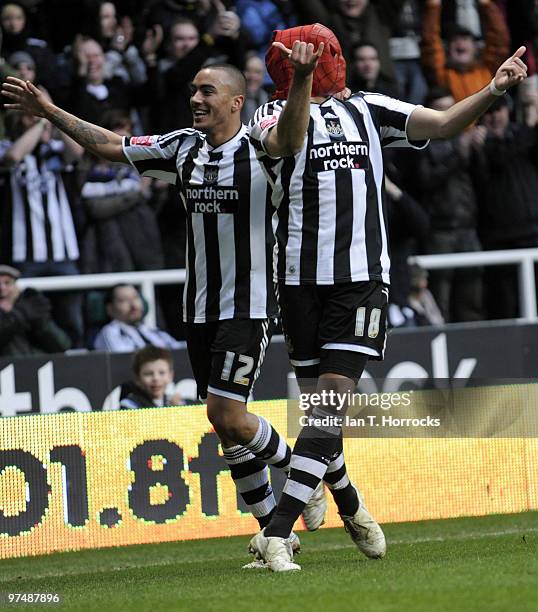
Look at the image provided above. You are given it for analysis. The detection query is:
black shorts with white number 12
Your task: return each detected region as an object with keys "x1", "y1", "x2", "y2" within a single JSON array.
[{"x1": 186, "y1": 319, "x2": 275, "y2": 402}]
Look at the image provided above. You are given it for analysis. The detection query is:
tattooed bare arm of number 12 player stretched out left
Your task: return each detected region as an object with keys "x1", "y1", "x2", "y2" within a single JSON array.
[{"x1": 2, "y1": 77, "x2": 128, "y2": 163}]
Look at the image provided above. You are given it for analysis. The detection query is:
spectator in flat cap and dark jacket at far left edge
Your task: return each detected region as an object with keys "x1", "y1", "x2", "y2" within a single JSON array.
[{"x1": 0, "y1": 265, "x2": 71, "y2": 357}]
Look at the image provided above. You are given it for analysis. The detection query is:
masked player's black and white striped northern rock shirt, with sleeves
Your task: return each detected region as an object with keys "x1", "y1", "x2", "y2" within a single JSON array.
[{"x1": 250, "y1": 92, "x2": 427, "y2": 285}]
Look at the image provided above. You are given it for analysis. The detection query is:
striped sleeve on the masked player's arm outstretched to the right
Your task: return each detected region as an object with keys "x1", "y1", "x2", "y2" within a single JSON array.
[{"x1": 363, "y1": 93, "x2": 429, "y2": 149}]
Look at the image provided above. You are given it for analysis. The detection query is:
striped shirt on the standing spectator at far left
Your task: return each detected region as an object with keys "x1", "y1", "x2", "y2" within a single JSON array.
[{"x1": 0, "y1": 139, "x2": 79, "y2": 264}]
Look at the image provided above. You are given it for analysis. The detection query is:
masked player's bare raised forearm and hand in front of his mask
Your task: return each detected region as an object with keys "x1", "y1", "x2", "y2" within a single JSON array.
[{"x1": 265, "y1": 40, "x2": 324, "y2": 157}]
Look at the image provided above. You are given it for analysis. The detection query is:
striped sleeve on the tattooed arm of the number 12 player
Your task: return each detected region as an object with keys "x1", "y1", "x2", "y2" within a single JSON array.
[{"x1": 123, "y1": 129, "x2": 196, "y2": 184}]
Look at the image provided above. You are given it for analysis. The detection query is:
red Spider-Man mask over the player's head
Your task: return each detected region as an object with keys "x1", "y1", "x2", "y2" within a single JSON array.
[{"x1": 265, "y1": 23, "x2": 346, "y2": 99}]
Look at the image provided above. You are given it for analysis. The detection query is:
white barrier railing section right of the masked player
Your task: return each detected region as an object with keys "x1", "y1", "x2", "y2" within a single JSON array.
[{"x1": 409, "y1": 249, "x2": 538, "y2": 322}]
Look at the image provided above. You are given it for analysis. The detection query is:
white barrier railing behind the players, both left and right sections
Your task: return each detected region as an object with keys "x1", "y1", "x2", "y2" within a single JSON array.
[{"x1": 14, "y1": 249, "x2": 538, "y2": 325}]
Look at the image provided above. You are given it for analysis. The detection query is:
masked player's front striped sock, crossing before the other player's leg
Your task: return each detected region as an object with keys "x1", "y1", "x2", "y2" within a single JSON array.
[{"x1": 264, "y1": 409, "x2": 341, "y2": 538}]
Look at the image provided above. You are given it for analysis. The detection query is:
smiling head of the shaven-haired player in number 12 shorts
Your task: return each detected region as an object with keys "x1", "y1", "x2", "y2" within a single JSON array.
[{"x1": 191, "y1": 67, "x2": 245, "y2": 134}]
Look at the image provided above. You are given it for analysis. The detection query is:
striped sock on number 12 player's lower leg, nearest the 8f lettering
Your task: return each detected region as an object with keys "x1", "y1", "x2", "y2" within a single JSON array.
[{"x1": 223, "y1": 446, "x2": 276, "y2": 529}]
